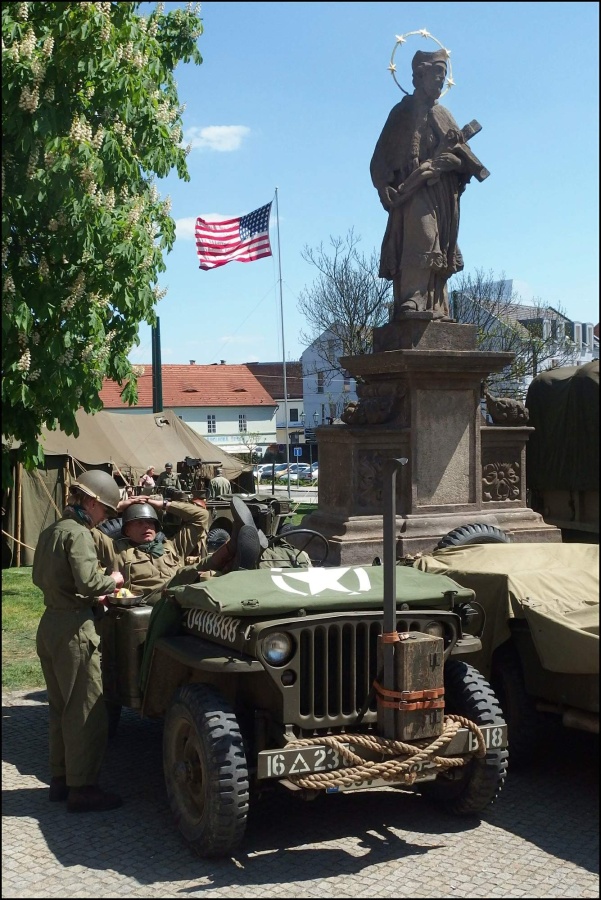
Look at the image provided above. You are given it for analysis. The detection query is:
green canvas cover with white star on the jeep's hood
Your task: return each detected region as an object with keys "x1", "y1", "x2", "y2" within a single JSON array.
[{"x1": 168, "y1": 566, "x2": 473, "y2": 617}]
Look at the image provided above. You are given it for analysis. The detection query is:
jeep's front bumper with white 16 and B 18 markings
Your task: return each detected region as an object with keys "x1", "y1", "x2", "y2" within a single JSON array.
[{"x1": 257, "y1": 725, "x2": 507, "y2": 778}]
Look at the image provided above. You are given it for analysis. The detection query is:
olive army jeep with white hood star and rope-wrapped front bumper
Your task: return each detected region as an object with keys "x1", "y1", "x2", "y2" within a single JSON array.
[{"x1": 100, "y1": 464, "x2": 508, "y2": 856}]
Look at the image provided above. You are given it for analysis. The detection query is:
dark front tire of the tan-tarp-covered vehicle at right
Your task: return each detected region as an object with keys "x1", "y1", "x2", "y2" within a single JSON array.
[{"x1": 490, "y1": 643, "x2": 546, "y2": 766}]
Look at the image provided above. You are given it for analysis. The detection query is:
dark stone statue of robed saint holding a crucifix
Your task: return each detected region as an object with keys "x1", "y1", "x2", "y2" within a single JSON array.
[{"x1": 370, "y1": 50, "x2": 489, "y2": 322}]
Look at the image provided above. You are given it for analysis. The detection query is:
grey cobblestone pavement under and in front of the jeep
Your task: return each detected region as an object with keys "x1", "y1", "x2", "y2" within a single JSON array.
[{"x1": 2, "y1": 691, "x2": 599, "y2": 900}]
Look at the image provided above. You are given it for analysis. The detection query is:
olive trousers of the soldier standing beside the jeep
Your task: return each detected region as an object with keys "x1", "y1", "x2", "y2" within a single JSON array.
[{"x1": 36, "y1": 609, "x2": 108, "y2": 787}]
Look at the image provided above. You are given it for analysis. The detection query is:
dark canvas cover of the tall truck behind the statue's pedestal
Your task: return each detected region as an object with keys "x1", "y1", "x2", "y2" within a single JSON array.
[{"x1": 526, "y1": 359, "x2": 599, "y2": 491}]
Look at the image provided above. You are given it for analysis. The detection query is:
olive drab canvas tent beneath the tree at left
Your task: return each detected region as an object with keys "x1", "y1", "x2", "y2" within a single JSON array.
[{"x1": 2, "y1": 409, "x2": 252, "y2": 568}]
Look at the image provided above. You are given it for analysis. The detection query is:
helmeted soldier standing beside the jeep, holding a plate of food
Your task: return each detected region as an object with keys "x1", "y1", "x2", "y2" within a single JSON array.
[{"x1": 32, "y1": 470, "x2": 123, "y2": 812}]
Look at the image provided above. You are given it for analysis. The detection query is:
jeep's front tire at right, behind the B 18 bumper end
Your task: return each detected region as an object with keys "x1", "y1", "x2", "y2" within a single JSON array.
[{"x1": 421, "y1": 659, "x2": 508, "y2": 816}]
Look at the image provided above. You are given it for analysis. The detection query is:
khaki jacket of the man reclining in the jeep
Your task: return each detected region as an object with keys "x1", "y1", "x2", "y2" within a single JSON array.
[{"x1": 92, "y1": 500, "x2": 209, "y2": 593}]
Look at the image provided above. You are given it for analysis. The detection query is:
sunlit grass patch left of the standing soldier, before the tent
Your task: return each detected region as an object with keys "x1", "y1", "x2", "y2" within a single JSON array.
[{"x1": 2, "y1": 566, "x2": 45, "y2": 691}]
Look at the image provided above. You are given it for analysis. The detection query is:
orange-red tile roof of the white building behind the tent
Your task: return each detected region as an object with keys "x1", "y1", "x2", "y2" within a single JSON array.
[{"x1": 100, "y1": 365, "x2": 275, "y2": 409}]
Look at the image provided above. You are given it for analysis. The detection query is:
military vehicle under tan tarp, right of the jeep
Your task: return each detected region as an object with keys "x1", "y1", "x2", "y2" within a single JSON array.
[{"x1": 411, "y1": 536, "x2": 599, "y2": 764}]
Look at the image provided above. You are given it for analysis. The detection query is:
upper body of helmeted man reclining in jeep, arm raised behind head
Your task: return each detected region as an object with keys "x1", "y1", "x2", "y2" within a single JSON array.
[{"x1": 92, "y1": 496, "x2": 209, "y2": 593}]
